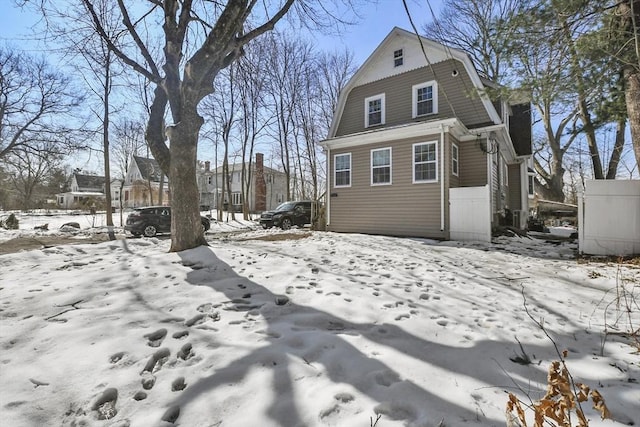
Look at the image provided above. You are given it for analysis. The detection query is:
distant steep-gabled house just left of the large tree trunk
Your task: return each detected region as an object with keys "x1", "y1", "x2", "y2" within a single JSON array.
[{"x1": 122, "y1": 156, "x2": 170, "y2": 208}]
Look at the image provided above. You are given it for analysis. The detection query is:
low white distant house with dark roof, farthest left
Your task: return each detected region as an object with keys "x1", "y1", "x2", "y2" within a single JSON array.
[{"x1": 56, "y1": 173, "x2": 121, "y2": 209}]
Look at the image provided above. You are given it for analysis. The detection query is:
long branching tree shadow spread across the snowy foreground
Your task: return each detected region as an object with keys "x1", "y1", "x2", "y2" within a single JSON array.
[{"x1": 169, "y1": 247, "x2": 620, "y2": 427}]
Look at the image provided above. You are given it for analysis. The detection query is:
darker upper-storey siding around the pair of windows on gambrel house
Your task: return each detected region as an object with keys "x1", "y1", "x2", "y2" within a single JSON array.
[{"x1": 336, "y1": 59, "x2": 491, "y2": 136}]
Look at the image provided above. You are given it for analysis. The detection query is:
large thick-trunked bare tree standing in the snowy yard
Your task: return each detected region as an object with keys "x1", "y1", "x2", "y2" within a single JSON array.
[{"x1": 72, "y1": 0, "x2": 362, "y2": 251}]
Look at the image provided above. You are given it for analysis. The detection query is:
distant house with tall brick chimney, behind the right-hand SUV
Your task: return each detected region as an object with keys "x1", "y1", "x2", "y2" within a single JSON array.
[{"x1": 198, "y1": 153, "x2": 287, "y2": 212}]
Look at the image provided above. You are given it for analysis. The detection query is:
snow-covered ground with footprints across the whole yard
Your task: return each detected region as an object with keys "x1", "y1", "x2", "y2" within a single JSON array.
[{"x1": 0, "y1": 211, "x2": 640, "y2": 427}]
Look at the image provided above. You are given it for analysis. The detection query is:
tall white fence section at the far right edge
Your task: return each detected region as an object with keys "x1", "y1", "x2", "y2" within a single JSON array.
[{"x1": 578, "y1": 180, "x2": 640, "y2": 255}]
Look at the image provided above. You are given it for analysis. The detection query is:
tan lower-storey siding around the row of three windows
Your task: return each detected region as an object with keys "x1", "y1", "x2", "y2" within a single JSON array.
[{"x1": 328, "y1": 134, "x2": 450, "y2": 238}]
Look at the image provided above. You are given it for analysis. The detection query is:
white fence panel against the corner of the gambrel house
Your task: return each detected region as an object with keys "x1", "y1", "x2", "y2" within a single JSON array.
[{"x1": 449, "y1": 185, "x2": 491, "y2": 242}]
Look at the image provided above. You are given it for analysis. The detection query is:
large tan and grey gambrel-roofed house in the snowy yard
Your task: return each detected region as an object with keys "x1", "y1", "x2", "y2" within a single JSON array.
[{"x1": 321, "y1": 28, "x2": 533, "y2": 240}]
